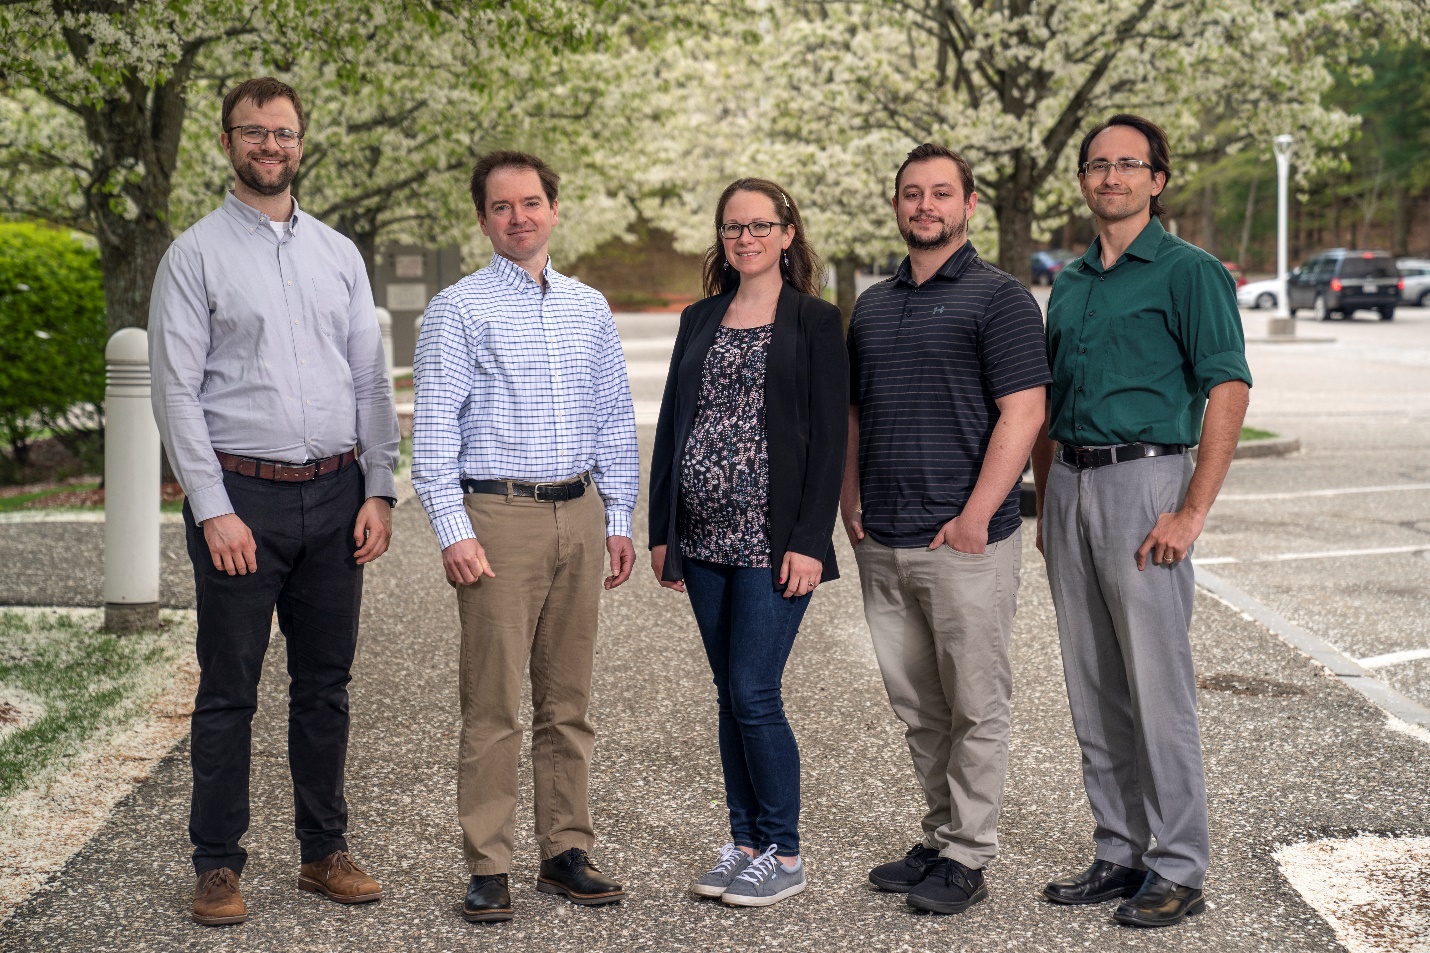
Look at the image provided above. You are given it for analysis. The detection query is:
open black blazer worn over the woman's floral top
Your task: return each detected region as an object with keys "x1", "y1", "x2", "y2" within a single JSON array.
[{"x1": 651, "y1": 283, "x2": 849, "y2": 588}]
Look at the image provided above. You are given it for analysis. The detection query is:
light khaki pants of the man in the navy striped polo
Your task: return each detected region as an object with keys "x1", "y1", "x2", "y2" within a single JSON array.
[{"x1": 854, "y1": 532, "x2": 1022, "y2": 869}]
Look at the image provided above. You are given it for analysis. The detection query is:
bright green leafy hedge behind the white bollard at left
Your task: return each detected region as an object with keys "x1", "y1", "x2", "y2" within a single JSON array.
[{"x1": 0, "y1": 223, "x2": 107, "y2": 465}]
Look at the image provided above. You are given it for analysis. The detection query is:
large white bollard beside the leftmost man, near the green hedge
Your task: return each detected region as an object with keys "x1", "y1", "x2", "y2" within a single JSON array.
[{"x1": 104, "y1": 328, "x2": 159, "y2": 632}]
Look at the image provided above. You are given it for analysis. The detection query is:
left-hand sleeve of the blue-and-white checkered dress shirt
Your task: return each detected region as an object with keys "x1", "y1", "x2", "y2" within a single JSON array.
[{"x1": 412, "y1": 295, "x2": 476, "y2": 549}]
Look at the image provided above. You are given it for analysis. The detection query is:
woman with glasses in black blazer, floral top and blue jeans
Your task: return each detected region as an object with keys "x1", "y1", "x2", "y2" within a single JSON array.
[{"x1": 651, "y1": 179, "x2": 849, "y2": 906}]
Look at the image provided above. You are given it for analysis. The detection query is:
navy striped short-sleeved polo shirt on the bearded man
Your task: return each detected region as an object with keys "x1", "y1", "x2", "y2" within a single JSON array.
[{"x1": 848, "y1": 243, "x2": 1052, "y2": 548}]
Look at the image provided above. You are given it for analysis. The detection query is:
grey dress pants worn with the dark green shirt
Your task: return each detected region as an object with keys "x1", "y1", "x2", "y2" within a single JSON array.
[{"x1": 1042, "y1": 455, "x2": 1211, "y2": 887}]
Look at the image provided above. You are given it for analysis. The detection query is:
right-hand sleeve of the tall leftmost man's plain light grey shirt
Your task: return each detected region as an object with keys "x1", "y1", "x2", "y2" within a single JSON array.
[{"x1": 347, "y1": 256, "x2": 402, "y2": 499}]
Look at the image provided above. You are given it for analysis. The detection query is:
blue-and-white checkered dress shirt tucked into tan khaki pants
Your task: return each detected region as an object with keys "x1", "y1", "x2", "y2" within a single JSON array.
[{"x1": 412, "y1": 255, "x2": 641, "y2": 549}]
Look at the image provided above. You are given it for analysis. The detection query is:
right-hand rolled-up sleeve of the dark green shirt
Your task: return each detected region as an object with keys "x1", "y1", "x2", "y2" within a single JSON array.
[{"x1": 1175, "y1": 260, "x2": 1251, "y2": 396}]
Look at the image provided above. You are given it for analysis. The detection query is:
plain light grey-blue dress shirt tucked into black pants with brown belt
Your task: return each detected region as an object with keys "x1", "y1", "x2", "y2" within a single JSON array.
[{"x1": 149, "y1": 192, "x2": 399, "y2": 522}]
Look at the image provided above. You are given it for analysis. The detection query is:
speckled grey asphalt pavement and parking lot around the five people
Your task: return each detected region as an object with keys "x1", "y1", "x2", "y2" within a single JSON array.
[{"x1": 0, "y1": 311, "x2": 1430, "y2": 952}]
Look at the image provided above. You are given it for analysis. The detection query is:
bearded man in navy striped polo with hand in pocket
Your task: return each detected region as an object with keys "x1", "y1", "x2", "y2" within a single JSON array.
[{"x1": 841, "y1": 143, "x2": 1051, "y2": 913}]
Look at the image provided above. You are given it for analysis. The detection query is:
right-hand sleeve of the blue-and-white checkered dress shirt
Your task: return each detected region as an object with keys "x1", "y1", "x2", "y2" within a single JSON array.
[{"x1": 592, "y1": 302, "x2": 641, "y2": 537}]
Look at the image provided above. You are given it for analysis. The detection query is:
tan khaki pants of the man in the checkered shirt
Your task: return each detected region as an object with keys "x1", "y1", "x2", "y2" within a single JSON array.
[{"x1": 458, "y1": 487, "x2": 606, "y2": 876}]
